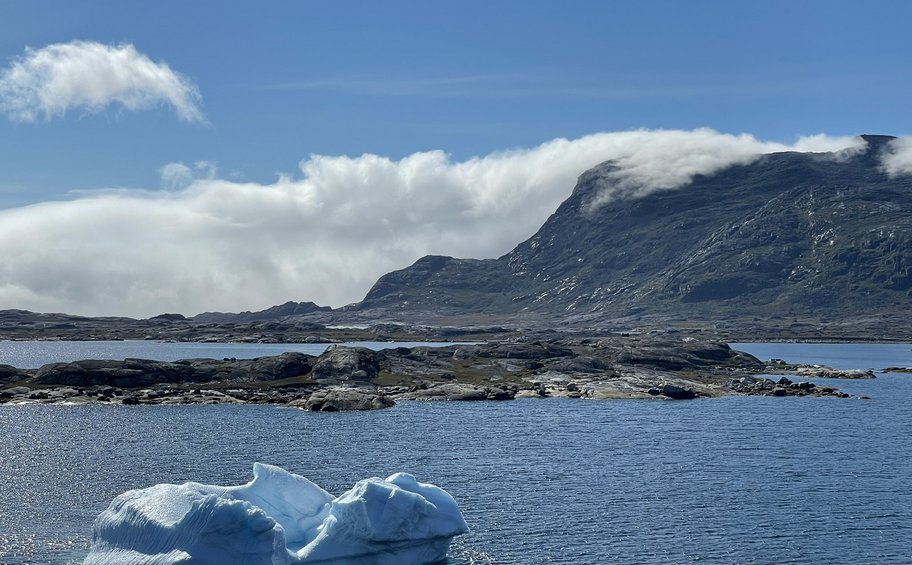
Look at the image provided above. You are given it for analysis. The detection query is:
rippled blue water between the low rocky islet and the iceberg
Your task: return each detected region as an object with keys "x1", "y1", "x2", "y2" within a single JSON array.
[{"x1": 0, "y1": 346, "x2": 912, "y2": 564}]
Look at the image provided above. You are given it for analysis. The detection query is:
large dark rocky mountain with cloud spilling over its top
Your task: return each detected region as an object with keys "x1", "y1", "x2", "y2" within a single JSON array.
[{"x1": 345, "y1": 135, "x2": 912, "y2": 324}]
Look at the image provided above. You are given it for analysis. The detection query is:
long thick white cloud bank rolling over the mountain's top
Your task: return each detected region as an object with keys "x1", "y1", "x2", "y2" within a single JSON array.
[{"x1": 0, "y1": 129, "x2": 856, "y2": 316}]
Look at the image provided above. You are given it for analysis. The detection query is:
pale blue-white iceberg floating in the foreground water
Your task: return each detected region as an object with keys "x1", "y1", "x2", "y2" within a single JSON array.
[{"x1": 84, "y1": 463, "x2": 468, "y2": 565}]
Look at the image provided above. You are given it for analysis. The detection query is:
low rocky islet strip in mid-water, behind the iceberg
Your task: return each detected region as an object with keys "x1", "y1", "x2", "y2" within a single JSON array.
[{"x1": 0, "y1": 335, "x2": 874, "y2": 411}]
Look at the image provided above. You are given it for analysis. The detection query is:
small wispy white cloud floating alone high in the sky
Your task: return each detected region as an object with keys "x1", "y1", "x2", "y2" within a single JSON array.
[{"x1": 0, "y1": 41, "x2": 205, "y2": 122}]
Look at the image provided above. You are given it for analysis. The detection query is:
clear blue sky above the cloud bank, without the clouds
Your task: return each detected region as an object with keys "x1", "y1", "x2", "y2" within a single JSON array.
[{"x1": 0, "y1": 0, "x2": 912, "y2": 207}]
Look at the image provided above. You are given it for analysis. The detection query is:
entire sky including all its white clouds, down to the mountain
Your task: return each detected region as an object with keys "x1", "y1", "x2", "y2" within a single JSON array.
[{"x1": 0, "y1": 0, "x2": 912, "y2": 316}]
